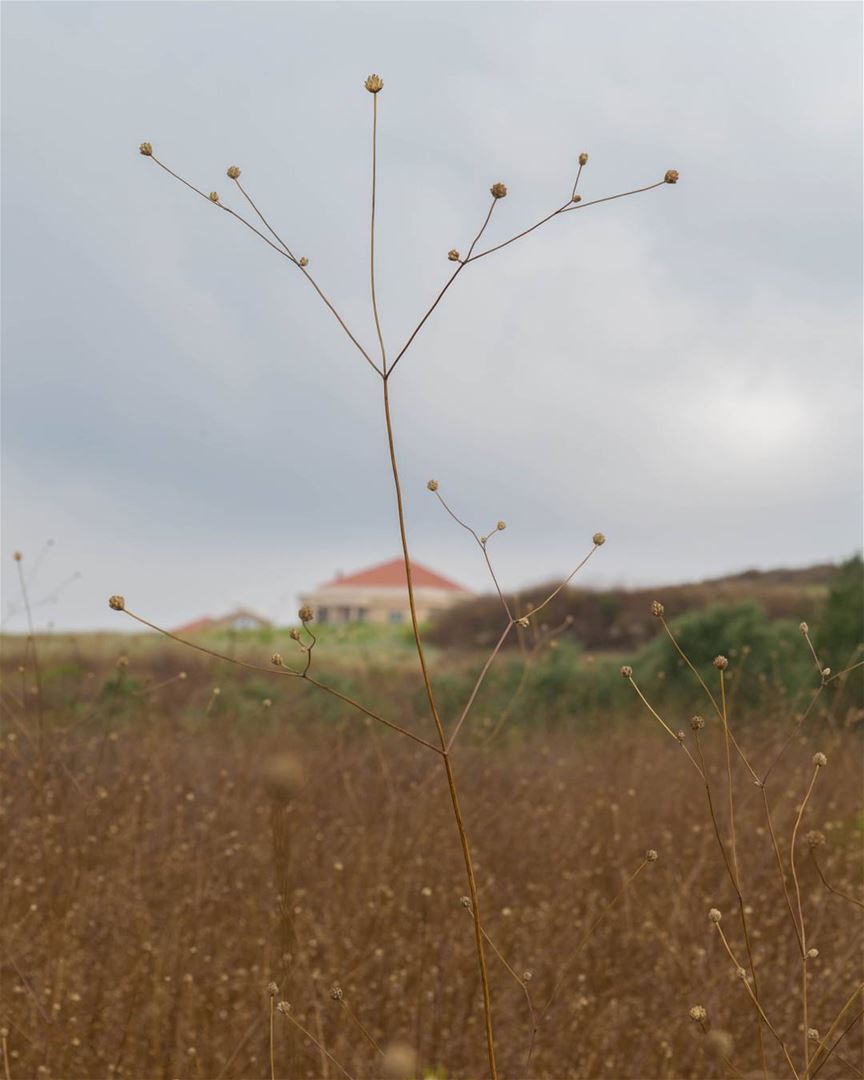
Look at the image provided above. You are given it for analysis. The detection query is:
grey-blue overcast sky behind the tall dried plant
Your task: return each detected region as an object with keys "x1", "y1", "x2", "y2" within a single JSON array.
[{"x1": 2, "y1": 2, "x2": 862, "y2": 629}]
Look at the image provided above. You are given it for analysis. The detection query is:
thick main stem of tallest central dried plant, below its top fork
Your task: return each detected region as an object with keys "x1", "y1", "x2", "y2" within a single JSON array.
[{"x1": 383, "y1": 378, "x2": 498, "y2": 1080}]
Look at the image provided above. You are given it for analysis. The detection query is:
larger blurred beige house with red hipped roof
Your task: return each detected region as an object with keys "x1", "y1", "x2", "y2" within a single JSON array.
[{"x1": 300, "y1": 556, "x2": 472, "y2": 625}]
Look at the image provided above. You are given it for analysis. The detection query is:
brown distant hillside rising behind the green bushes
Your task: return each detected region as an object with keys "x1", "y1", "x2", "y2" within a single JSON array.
[{"x1": 428, "y1": 563, "x2": 837, "y2": 651}]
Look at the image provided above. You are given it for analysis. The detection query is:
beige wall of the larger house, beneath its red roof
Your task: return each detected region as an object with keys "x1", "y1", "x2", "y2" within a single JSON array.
[{"x1": 300, "y1": 585, "x2": 471, "y2": 625}]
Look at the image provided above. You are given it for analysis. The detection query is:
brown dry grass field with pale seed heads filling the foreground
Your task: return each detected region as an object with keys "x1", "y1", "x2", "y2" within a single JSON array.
[{"x1": 0, "y1": 635, "x2": 864, "y2": 1080}]
